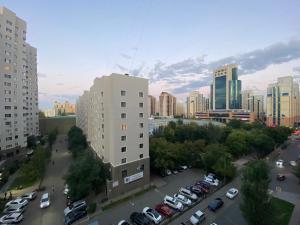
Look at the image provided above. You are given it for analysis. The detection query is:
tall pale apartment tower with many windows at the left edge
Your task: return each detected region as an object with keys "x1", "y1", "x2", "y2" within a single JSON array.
[{"x1": 0, "y1": 7, "x2": 39, "y2": 158}]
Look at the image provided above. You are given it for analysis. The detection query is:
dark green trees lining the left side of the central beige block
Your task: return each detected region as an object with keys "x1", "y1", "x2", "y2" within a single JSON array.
[{"x1": 66, "y1": 126, "x2": 108, "y2": 200}]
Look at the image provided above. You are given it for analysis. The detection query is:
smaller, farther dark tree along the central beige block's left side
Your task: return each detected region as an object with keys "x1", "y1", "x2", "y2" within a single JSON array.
[{"x1": 68, "y1": 126, "x2": 87, "y2": 158}]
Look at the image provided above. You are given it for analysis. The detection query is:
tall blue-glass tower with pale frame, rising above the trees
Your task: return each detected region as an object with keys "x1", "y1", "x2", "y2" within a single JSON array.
[{"x1": 211, "y1": 64, "x2": 242, "y2": 110}]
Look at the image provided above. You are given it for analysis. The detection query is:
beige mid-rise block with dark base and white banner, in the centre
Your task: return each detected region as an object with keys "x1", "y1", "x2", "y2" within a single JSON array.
[{"x1": 76, "y1": 74, "x2": 150, "y2": 198}]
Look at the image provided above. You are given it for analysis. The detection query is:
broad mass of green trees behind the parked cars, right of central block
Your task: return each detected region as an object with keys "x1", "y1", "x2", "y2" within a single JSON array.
[{"x1": 150, "y1": 120, "x2": 291, "y2": 178}]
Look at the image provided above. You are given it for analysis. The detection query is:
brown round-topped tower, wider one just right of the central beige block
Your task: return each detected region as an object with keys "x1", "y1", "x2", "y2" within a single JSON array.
[{"x1": 159, "y1": 92, "x2": 176, "y2": 117}]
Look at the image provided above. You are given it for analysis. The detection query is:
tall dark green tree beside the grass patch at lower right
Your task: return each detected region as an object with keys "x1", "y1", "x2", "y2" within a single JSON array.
[{"x1": 240, "y1": 160, "x2": 274, "y2": 225}]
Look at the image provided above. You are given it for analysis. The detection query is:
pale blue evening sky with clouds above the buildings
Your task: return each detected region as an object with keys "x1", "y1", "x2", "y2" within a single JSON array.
[{"x1": 0, "y1": 0, "x2": 300, "y2": 109}]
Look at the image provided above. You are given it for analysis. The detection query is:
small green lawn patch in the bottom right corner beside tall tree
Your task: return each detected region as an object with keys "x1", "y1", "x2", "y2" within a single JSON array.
[{"x1": 271, "y1": 197, "x2": 295, "y2": 225}]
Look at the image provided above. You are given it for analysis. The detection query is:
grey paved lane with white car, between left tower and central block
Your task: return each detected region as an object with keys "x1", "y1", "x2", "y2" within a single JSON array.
[{"x1": 21, "y1": 135, "x2": 72, "y2": 225}]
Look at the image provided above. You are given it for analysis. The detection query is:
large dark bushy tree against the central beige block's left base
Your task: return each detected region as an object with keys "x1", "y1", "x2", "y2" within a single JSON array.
[{"x1": 66, "y1": 152, "x2": 108, "y2": 200}]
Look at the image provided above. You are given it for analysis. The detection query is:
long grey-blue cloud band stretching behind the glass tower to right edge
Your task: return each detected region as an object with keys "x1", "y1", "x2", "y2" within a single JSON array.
[{"x1": 126, "y1": 40, "x2": 300, "y2": 94}]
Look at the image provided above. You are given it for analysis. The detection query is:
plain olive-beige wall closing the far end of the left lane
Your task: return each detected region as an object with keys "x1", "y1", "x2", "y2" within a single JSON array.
[{"x1": 40, "y1": 116, "x2": 76, "y2": 135}]
